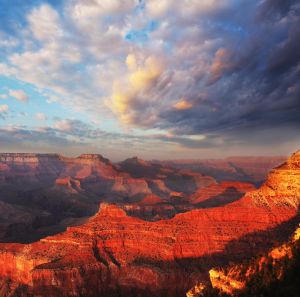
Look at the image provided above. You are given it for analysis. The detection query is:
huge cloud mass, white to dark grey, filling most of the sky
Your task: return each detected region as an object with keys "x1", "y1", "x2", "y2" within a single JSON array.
[{"x1": 0, "y1": 0, "x2": 300, "y2": 157}]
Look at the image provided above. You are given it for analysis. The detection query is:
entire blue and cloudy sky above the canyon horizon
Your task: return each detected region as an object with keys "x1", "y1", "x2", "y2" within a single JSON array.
[{"x1": 0, "y1": 0, "x2": 300, "y2": 160}]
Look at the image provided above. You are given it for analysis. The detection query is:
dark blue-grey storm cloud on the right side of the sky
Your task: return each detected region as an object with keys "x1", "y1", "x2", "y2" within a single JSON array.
[{"x1": 144, "y1": 1, "x2": 300, "y2": 146}]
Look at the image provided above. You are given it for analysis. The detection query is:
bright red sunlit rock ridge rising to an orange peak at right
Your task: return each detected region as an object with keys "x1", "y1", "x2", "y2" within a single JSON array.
[{"x1": 0, "y1": 152, "x2": 300, "y2": 297}]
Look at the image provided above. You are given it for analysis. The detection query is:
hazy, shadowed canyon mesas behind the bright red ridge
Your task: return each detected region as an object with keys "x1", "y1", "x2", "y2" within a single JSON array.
[{"x1": 0, "y1": 153, "x2": 268, "y2": 243}]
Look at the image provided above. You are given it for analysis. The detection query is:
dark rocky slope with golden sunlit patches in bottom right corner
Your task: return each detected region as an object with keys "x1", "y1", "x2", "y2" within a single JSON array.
[{"x1": 186, "y1": 227, "x2": 300, "y2": 297}]
